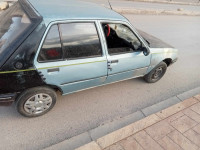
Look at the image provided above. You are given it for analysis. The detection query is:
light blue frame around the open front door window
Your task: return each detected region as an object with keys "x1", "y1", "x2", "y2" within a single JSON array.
[{"x1": 99, "y1": 20, "x2": 149, "y2": 56}]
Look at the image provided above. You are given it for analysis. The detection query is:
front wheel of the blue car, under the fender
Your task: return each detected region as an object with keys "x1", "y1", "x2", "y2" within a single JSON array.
[{"x1": 144, "y1": 62, "x2": 167, "y2": 83}]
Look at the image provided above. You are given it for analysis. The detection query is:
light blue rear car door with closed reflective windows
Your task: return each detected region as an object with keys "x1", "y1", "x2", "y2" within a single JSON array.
[{"x1": 35, "y1": 22, "x2": 107, "y2": 94}]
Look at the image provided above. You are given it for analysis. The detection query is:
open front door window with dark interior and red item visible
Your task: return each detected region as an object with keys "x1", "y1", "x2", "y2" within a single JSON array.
[{"x1": 102, "y1": 23, "x2": 142, "y2": 55}]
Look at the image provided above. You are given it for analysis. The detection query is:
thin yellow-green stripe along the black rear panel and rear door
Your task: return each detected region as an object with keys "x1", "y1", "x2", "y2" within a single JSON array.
[{"x1": 0, "y1": 60, "x2": 107, "y2": 74}]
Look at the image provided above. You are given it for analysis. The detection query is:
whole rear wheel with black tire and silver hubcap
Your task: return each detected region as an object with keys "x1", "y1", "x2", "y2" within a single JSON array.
[{"x1": 16, "y1": 87, "x2": 57, "y2": 117}]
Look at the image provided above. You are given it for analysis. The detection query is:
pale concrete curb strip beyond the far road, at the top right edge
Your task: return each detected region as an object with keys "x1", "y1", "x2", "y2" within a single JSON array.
[{"x1": 127, "y1": 0, "x2": 200, "y2": 6}]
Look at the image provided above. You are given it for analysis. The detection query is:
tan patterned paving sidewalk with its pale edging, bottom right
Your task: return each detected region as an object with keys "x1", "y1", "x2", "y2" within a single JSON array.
[{"x1": 76, "y1": 95, "x2": 200, "y2": 150}]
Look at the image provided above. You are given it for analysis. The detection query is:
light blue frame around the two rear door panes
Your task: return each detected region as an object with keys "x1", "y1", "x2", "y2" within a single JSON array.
[{"x1": 35, "y1": 20, "x2": 106, "y2": 63}]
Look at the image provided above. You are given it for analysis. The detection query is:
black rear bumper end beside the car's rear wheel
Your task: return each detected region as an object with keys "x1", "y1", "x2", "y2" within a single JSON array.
[{"x1": 0, "y1": 93, "x2": 17, "y2": 106}]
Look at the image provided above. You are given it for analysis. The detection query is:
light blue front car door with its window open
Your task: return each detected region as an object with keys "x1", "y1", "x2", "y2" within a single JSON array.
[{"x1": 101, "y1": 21, "x2": 151, "y2": 83}]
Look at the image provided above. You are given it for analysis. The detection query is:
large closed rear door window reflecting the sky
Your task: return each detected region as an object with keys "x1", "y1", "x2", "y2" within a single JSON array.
[{"x1": 59, "y1": 23, "x2": 102, "y2": 59}]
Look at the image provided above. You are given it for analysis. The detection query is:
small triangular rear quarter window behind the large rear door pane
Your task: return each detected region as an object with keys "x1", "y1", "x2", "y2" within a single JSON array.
[{"x1": 38, "y1": 25, "x2": 63, "y2": 62}]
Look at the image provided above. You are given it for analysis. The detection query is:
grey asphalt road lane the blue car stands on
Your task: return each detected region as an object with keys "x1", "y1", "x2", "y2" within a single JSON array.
[{"x1": 0, "y1": 15, "x2": 200, "y2": 150}]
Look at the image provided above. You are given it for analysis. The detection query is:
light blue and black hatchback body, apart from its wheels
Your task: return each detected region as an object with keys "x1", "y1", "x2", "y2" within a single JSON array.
[{"x1": 0, "y1": 0, "x2": 178, "y2": 117}]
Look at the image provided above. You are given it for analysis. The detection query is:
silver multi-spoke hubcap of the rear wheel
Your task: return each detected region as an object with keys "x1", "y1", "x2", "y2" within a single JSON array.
[{"x1": 24, "y1": 93, "x2": 52, "y2": 114}]
